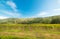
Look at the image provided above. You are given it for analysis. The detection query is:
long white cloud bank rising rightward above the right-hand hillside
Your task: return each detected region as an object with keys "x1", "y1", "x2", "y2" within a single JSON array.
[{"x1": 32, "y1": 8, "x2": 60, "y2": 17}]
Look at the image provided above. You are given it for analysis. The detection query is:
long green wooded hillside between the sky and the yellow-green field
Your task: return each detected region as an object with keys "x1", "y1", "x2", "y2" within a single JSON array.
[{"x1": 0, "y1": 15, "x2": 60, "y2": 24}]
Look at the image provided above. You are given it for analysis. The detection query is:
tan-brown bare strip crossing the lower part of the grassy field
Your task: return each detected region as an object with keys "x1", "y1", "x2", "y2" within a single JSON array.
[{"x1": 0, "y1": 32, "x2": 60, "y2": 39}]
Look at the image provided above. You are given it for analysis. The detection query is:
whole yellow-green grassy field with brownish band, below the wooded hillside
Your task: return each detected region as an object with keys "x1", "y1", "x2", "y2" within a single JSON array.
[{"x1": 0, "y1": 24, "x2": 60, "y2": 39}]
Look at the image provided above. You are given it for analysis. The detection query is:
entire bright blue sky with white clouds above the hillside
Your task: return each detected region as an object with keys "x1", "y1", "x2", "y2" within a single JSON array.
[{"x1": 0, "y1": 0, "x2": 60, "y2": 19}]
